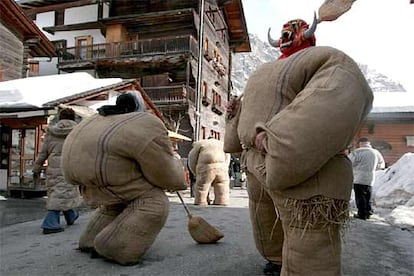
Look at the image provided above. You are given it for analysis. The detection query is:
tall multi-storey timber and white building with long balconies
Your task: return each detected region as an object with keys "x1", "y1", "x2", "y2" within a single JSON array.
[{"x1": 18, "y1": 0, "x2": 250, "y2": 157}]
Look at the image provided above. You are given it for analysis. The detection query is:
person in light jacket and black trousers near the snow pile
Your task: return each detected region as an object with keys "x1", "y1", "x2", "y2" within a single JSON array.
[{"x1": 348, "y1": 137, "x2": 385, "y2": 220}]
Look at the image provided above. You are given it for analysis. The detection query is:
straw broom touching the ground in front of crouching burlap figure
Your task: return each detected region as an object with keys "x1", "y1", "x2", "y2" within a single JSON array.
[{"x1": 176, "y1": 192, "x2": 224, "y2": 244}]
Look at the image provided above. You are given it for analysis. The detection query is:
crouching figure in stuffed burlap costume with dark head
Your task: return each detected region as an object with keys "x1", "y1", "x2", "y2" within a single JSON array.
[{"x1": 62, "y1": 93, "x2": 187, "y2": 265}]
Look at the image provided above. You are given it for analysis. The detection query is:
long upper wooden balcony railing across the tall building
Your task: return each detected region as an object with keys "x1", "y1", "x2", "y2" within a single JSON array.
[{"x1": 59, "y1": 36, "x2": 198, "y2": 65}]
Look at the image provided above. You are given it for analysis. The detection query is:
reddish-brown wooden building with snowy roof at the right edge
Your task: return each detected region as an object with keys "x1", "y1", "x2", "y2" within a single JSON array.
[{"x1": 353, "y1": 92, "x2": 414, "y2": 167}]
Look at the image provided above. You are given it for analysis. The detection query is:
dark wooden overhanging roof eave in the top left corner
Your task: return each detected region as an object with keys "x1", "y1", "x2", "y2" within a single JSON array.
[{"x1": 0, "y1": 0, "x2": 55, "y2": 57}]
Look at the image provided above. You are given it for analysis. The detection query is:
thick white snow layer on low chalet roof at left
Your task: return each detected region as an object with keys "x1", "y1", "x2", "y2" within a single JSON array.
[{"x1": 0, "y1": 72, "x2": 122, "y2": 108}]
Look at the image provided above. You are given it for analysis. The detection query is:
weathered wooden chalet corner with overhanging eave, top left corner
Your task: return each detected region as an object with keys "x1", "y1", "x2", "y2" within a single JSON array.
[{"x1": 0, "y1": 0, "x2": 55, "y2": 81}]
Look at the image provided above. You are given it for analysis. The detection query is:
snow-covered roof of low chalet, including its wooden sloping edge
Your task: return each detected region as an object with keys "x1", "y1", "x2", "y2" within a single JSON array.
[{"x1": 0, "y1": 72, "x2": 164, "y2": 121}]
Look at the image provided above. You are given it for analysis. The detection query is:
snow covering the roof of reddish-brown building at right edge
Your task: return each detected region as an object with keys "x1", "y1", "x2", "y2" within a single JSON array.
[{"x1": 371, "y1": 92, "x2": 414, "y2": 113}]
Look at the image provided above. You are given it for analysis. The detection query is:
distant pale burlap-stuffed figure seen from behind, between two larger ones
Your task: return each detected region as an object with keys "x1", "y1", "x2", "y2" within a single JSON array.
[{"x1": 188, "y1": 139, "x2": 230, "y2": 206}]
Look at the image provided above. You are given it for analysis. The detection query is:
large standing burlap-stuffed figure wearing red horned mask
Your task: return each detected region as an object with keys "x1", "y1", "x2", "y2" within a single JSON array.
[{"x1": 224, "y1": 19, "x2": 373, "y2": 276}]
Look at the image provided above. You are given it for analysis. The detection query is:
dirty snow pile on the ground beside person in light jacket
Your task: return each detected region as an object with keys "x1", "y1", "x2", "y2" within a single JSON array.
[{"x1": 373, "y1": 153, "x2": 414, "y2": 226}]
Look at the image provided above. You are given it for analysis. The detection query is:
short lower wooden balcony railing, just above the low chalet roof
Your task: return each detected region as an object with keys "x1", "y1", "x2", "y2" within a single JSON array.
[{"x1": 144, "y1": 85, "x2": 195, "y2": 104}]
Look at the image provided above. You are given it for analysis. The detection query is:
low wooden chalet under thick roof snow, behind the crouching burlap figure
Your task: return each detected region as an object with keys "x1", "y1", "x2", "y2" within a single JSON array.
[{"x1": 0, "y1": 73, "x2": 164, "y2": 197}]
